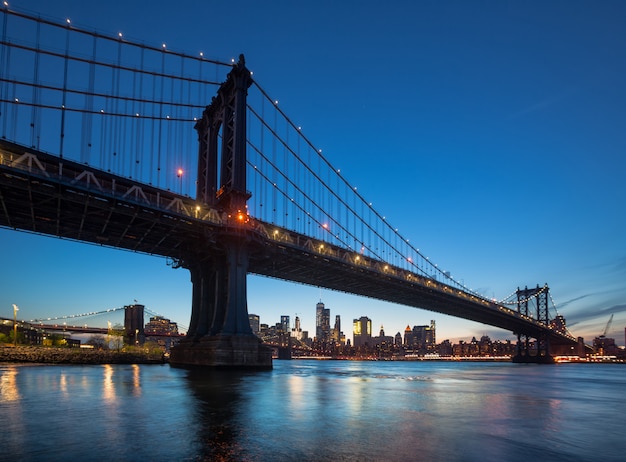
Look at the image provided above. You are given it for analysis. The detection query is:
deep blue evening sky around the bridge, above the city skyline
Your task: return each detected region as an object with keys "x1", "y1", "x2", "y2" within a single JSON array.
[{"x1": 0, "y1": 0, "x2": 626, "y2": 345}]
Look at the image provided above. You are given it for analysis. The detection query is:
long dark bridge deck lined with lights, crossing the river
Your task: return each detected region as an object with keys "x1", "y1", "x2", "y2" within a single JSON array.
[{"x1": 0, "y1": 140, "x2": 576, "y2": 344}]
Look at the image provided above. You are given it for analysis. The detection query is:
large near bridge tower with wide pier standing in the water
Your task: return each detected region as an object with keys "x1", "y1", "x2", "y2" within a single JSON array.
[{"x1": 170, "y1": 55, "x2": 272, "y2": 368}]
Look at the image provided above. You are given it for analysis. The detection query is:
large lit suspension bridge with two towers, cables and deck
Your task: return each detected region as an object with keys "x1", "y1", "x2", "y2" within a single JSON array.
[{"x1": 0, "y1": 5, "x2": 581, "y2": 367}]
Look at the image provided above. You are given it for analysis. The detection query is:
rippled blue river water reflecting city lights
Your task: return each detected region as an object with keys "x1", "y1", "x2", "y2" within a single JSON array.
[{"x1": 0, "y1": 360, "x2": 626, "y2": 462}]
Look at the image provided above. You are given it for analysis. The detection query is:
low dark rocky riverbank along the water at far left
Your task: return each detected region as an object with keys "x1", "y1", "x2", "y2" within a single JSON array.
[{"x1": 0, "y1": 345, "x2": 167, "y2": 364}]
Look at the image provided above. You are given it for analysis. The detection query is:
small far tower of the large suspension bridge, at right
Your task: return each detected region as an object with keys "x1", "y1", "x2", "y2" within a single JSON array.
[{"x1": 513, "y1": 284, "x2": 553, "y2": 363}]
